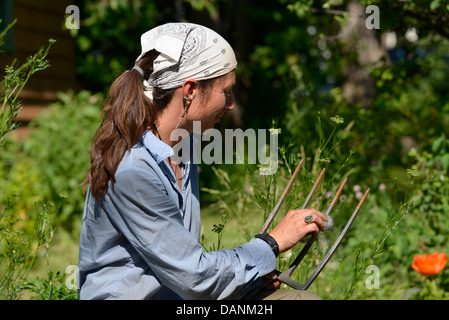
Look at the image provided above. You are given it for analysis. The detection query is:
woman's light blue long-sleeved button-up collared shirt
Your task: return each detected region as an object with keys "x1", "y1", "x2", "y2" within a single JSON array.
[{"x1": 78, "y1": 131, "x2": 276, "y2": 299}]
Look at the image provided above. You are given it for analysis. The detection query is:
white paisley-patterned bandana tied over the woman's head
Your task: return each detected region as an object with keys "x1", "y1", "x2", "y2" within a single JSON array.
[{"x1": 136, "y1": 23, "x2": 237, "y2": 98}]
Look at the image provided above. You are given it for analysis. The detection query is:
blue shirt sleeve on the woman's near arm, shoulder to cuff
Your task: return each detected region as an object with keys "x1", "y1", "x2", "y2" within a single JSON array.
[{"x1": 105, "y1": 168, "x2": 276, "y2": 299}]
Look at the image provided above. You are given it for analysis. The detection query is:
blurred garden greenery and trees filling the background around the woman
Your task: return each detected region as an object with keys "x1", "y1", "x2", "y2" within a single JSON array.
[{"x1": 0, "y1": 0, "x2": 449, "y2": 299}]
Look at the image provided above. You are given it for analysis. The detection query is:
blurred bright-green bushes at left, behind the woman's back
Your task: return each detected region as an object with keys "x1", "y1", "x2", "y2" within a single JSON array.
[{"x1": 0, "y1": 88, "x2": 101, "y2": 299}]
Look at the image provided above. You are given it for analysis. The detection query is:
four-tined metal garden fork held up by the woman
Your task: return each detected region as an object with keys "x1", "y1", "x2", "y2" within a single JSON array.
[{"x1": 259, "y1": 160, "x2": 370, "y2": 290}]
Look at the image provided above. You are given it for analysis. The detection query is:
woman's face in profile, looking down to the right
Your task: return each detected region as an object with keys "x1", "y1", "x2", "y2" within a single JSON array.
[{"x1": 186, "y1": 71, "x2": 235, "y2": 132}]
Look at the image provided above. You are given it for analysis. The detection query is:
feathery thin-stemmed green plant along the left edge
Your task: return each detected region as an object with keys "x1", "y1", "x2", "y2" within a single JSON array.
[{"x1": 0, "y1": 22, "x2": 65, "y2": 299}]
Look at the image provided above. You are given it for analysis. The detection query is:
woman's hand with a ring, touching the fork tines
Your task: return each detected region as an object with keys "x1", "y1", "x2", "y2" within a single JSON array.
[{"x1": 270, "y1": 209, "x2": 327, "y2": 252}]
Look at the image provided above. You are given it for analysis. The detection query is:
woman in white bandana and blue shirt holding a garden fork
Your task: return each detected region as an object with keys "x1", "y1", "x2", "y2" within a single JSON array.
[{"x1": 78, "y1": 23, "x2": 326, "y2": 299}]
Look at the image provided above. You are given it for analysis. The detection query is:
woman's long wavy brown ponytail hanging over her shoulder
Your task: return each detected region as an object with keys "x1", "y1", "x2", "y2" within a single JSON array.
[{"x1": 82, "y1": 50, "x2": 162, "y2": 200}]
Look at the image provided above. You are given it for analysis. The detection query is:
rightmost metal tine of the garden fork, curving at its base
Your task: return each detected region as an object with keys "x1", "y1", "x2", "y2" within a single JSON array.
[{"x1": 279, "y1": 189, "x2": 370, "y2": 290}]
